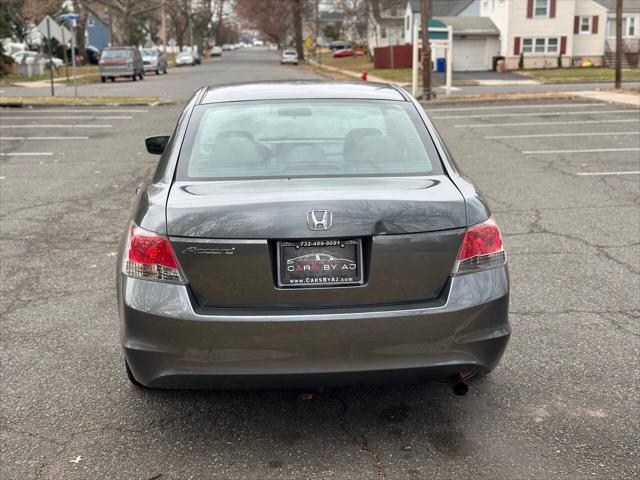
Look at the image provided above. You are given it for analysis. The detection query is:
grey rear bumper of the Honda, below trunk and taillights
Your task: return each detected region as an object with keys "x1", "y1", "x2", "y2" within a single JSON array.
[{"x1": 119, "y1": 267, "x2": 511, "y2": 388}]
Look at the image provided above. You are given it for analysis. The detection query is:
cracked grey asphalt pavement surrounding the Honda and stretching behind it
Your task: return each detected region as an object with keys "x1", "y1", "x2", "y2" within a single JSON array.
[{"x1": 0, "y1": 47, "x2": 640, "y2": 480}]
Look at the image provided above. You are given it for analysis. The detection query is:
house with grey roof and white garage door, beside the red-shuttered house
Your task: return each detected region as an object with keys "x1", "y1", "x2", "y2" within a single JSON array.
[{"x1": 404, "y1": 0, "x2": 500, "y2": 71}]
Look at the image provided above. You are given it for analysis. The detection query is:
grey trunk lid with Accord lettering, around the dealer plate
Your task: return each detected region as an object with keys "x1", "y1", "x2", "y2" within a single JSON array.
[{"x1": 167, "y1": 176, "x2": 466, "y2": 308}]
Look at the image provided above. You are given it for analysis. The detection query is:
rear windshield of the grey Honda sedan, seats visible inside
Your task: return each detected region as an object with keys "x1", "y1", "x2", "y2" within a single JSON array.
[{"x1": 178, "y1": 100, "x2": 442, "y2": 180}]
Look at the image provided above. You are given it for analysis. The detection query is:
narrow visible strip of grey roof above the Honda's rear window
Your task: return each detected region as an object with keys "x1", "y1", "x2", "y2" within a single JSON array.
[{"x1": 200, "y1": 80, "x2": 407, "y2": 104}]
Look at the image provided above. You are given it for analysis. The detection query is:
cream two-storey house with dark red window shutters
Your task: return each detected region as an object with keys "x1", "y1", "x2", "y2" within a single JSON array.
[{"x1": 482, "y1": 0, "x2": 640, "y2": 69}]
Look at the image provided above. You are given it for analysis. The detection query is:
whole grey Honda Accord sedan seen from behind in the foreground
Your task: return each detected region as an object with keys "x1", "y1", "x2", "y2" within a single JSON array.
[{"x1": 117, "y1": 82, "x2": 511, "y2": 393}]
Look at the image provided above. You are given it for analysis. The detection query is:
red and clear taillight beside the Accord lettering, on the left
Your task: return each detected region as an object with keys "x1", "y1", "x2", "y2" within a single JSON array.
[{"x1": 122, "y1": 224, "x2": 184, "y2": 283}]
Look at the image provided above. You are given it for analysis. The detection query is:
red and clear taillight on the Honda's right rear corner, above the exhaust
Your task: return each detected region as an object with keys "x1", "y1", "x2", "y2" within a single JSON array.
[{"x1": 453, "y1": 219, "x2": 507, "y2": 275}]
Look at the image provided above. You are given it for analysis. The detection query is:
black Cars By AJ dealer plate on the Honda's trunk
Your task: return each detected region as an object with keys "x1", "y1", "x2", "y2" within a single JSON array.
[{"x1": 278, "y1": 239, "x2": 363, "y2": 287}]
